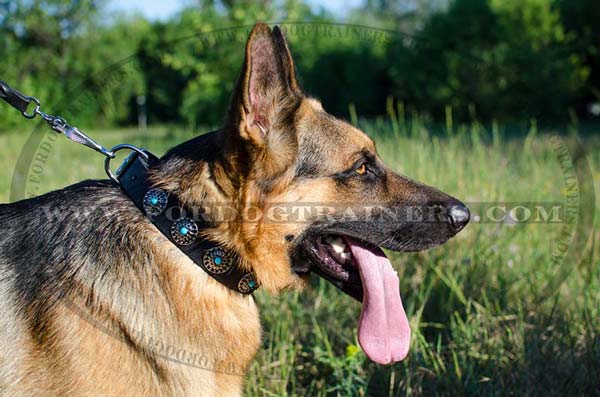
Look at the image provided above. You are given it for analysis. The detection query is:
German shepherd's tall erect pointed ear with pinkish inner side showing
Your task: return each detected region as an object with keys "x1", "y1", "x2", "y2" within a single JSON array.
[{"x1": 230, "y1": 23, "x2": 301, "y2": 146}]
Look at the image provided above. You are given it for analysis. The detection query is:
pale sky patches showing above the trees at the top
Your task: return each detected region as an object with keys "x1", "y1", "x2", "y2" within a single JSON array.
[{"x1": 109, "y1": 0, "x2": 362, "y2": 20}]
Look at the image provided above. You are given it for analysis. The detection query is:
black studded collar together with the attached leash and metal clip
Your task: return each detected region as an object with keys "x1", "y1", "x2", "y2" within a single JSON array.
[{"x1": 0, "y1": 81, "x2": 259, "y2": 294}]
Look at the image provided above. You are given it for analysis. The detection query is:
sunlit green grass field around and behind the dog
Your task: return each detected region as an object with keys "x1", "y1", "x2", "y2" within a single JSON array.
[{"x1": 0, "y1": 118, "x2": 600, "y2": 396}]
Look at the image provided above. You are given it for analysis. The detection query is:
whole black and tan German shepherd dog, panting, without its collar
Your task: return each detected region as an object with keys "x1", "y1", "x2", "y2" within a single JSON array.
[{"x1": 0, "y1": 24, "x2": 469, "y2": 397}]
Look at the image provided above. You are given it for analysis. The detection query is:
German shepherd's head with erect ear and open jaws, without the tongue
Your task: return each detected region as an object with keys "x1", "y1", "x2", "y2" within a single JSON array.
[{"x1": 220, "y1": 24, "x2": 469, "y2": 290}]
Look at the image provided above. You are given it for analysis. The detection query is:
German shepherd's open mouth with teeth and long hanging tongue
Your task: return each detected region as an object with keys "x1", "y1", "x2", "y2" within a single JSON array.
[{"x1": 294, "y1": 234, "x2": 410, "y2": 364}]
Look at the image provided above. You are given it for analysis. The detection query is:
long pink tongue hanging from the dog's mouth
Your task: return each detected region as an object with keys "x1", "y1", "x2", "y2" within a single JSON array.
[{"x1": 347, "y1": 239, "x2": 410, "y2": 364}]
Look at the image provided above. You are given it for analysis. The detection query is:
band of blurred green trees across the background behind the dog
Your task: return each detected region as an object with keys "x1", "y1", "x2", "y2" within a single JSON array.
[{"x1": 0, "y1": 0, "x2": 600, "y2": 129}]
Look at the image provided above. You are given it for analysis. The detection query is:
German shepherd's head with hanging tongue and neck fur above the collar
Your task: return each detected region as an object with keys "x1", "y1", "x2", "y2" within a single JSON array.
[{"x1": 158, "y1": 24, "x2": 469, "y2": 363}]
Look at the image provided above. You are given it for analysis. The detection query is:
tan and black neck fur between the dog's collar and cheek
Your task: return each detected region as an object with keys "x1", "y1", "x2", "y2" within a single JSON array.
[{"x1": 151, "y1": 129, "x2": 303, "y2": 293}]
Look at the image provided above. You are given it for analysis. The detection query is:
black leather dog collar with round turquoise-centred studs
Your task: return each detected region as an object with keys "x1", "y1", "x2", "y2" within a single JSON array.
[{"x1": 117, "y1": 151, "x2": 259, "y2": 294}]
